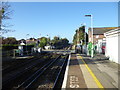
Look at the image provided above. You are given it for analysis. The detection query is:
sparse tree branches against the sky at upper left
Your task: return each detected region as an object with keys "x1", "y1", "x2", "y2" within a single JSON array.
[{"x1": 0, "y1": 2, "x2": 14, "y2": 35}]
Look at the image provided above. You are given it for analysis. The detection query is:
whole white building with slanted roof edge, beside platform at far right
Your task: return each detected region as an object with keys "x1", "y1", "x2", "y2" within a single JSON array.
[{"x1": 104, "y1": 28, "x2": 120, "y2": 64}]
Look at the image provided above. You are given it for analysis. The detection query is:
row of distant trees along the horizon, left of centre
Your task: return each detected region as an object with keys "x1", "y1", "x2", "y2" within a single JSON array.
[{"x1": 0, "y1": 36, "x2": 70, "y2": 49}]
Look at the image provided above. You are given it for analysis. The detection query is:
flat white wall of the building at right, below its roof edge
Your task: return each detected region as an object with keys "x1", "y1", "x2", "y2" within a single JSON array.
[{"x1": 105, "y1": 31, "x2": 120, "y2": 63}]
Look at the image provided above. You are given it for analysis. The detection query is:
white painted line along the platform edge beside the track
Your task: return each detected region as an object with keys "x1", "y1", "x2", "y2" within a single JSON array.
[{"x1": 61, "y1": 54, "x2": 71, "y2": 90}]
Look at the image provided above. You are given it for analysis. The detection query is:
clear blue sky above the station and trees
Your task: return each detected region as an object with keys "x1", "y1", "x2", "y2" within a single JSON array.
[{"x1": 3, "y1": 2, "x2": 118, "y2": 42}]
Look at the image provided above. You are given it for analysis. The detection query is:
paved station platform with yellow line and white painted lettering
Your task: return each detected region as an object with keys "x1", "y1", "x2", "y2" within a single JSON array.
[{"x1": 62, "y1": 53, "x2": 118, "y2": 90}]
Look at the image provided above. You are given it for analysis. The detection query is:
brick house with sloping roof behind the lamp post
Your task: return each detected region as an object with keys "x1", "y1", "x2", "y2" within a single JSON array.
[{"x1": 88, "y1": 27, "x2": 118, "y2": 53}]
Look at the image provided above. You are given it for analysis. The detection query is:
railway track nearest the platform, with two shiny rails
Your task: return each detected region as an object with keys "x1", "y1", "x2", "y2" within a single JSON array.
[{"x1": 17, "y1": 56, "x2": 68, "y2": 90}]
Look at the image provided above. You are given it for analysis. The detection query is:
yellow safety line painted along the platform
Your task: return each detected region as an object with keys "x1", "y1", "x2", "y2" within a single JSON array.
[{"x1": 80, "y1": 53, "x2": 104, "y2": 90}]
